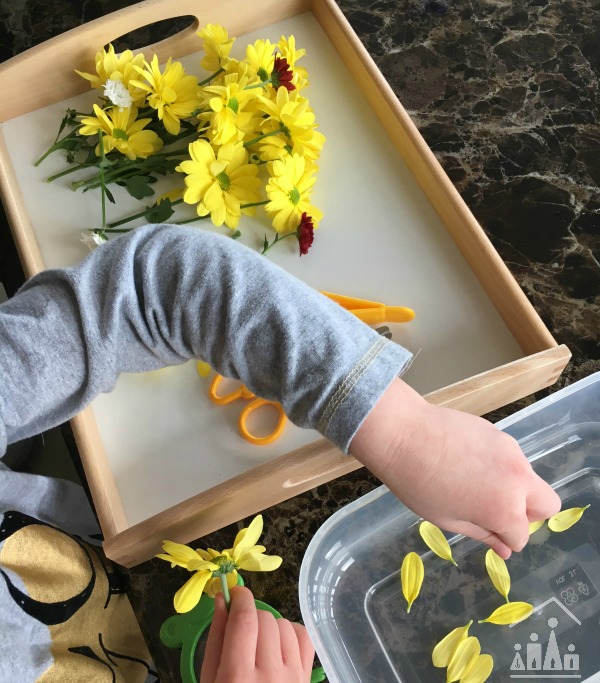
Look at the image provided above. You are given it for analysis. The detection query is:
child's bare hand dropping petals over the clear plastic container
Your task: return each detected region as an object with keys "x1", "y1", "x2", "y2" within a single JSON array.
[{"x1": 350, "y1": 379, "x2": 561, "y2": 559}]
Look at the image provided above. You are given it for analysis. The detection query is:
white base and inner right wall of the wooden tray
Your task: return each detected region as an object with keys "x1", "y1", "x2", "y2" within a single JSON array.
[{"x1": 1, "y1": 13, "x2": 523, "y2": 524}]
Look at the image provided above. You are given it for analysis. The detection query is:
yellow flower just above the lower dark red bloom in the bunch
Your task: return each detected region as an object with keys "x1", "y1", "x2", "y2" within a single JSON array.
[{"x1": 265, "y1": 154, "x2": 323, "y2": 233}]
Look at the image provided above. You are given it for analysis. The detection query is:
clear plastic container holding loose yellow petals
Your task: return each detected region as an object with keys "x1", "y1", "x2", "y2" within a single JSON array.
[{"x1": 299, "y1": 373, "x2": 600, "y2": 683}]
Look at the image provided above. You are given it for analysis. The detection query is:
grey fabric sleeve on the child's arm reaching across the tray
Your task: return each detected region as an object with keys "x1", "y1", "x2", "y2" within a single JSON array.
[{"x1": 0, "y1": 225, "x2": 410, "y2": 455}]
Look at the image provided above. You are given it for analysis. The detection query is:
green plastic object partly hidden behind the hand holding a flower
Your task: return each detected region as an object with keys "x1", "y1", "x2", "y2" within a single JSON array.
[{"x1": 160, "y1": 574, "x2": 325, "y2": 683}]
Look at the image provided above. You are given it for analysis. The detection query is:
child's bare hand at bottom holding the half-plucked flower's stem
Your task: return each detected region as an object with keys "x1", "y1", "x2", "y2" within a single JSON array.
[{"x1": 200, "y1": 586, "x2": 315, "y2": 683}]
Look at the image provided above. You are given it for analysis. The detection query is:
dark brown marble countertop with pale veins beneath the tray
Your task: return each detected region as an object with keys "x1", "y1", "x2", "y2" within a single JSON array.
[{"x1": 0, "y1": 0, "x2": 600, "y2": 681}]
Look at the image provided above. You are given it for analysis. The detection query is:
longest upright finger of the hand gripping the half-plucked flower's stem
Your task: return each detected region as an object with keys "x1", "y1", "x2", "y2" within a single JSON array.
[{"x1": 223, "y1": 586, "x2": 258, "y2": 671}]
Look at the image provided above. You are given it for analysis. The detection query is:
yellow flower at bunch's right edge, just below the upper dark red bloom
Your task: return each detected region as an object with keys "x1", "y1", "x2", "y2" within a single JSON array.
[{"x1": 259, "y1": 88, "x2": 325, "y2": 161}]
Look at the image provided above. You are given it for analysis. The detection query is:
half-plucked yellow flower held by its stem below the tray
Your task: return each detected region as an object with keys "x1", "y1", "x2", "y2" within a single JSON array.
[{"x1": 156, "y1": 515, "x2": 283, "y2": 612}]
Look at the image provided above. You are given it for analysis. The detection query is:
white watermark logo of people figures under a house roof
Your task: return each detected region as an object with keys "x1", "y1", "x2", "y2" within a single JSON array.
[{"x1": 510, "y1": 597, "x2": 581, "y2": 681}]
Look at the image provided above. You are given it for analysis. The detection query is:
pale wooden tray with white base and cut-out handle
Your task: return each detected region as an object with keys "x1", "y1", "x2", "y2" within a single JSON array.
[{"x1": 0, "y1": 0, "x2": 570, "y2": 566}]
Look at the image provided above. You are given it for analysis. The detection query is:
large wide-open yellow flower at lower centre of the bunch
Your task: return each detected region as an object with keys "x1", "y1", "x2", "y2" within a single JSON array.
[{"x1": 176, "y1": 140, "x2": 260, "y2": 229}]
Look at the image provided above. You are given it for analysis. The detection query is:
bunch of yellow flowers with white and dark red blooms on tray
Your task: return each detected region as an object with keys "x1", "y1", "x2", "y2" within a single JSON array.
[{"x1": 37, "y1": 24, "x2": 325, "y2": 255}]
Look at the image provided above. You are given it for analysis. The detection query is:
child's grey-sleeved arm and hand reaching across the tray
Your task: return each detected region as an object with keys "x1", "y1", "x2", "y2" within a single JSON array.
[{"x1": 0, "y1": 226, "x2": 559, "y2": 556}]
